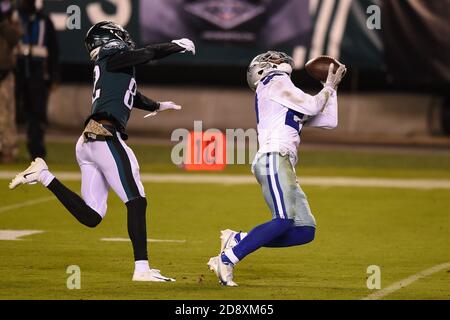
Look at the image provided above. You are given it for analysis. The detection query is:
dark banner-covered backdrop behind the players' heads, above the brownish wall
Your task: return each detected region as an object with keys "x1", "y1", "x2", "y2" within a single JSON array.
[{"x1": 39, "y1": 0, "x2": 450, "y2": 139}]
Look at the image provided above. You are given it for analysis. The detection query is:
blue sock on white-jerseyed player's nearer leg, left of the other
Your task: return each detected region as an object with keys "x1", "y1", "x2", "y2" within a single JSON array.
[{"x1": 227, "y1": 219, "x2": 294, "y2": 261}]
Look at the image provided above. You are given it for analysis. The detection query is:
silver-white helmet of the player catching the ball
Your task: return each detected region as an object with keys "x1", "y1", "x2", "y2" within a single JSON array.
[{"x1": 247, "y1": 51, "x2": 294, "y2": 91}]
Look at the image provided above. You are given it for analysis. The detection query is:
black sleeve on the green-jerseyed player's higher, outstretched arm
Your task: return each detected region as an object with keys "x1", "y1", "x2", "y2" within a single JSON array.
[{"x1": 106, "y1": 42, "x2": 184, "y2": 71}]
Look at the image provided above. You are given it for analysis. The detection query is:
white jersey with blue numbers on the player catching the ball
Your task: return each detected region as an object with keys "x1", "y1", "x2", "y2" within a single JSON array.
[{"x1": 255, "y1": 71, "x2": 337, "y2": 165}]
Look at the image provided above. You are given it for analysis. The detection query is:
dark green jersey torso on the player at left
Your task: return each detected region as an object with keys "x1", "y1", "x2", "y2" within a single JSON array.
[{"x1": 91, "y1": 40, "x2": 137, "y2": 131}]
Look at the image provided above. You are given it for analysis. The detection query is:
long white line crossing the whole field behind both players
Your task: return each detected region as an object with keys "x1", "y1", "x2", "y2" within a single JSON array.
[{"x1": 0, "y1": 171, "x2": 450, "y2": 189}]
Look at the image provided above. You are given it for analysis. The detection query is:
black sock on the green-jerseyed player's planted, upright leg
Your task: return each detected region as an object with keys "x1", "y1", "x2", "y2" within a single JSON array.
[{"x1": 126, "y1": 197, "x2": 148, "y2": 261}]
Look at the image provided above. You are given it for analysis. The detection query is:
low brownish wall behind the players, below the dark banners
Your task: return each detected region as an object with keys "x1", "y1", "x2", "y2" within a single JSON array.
[{"x1": 49, "y1": 84, "x2": 440, "y2": 137}]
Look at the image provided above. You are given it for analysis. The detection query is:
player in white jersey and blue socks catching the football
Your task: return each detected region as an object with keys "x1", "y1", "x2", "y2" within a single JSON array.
[{"x1": 208, "y1": 51, "x2": 346, "y2": 286}]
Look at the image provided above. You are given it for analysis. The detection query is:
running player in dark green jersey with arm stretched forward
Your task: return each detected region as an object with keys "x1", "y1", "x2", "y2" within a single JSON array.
[{"x1": 10, "y1": 21, "x2": 195, "y2": 281}]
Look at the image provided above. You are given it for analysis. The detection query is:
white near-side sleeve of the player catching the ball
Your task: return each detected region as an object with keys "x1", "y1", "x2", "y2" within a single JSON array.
[{"x1": 270, "y1": 78, "x2": 335, "y2": 116}]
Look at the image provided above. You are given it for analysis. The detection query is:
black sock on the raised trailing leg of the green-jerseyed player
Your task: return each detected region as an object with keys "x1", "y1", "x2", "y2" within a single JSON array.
[{"x1": 48, "y1": 178, "x2": 102, "y2": 228}]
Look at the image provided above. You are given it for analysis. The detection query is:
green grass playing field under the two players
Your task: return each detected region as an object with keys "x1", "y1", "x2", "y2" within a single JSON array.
[{"x1": 0, "y1": 143, "x2": 450, "y2": 299}]
